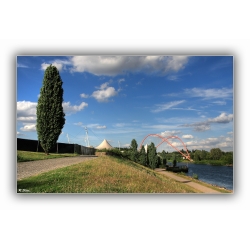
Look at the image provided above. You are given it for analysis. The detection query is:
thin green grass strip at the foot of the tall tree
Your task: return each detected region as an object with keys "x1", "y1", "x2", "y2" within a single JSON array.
[{"x1": 17, "y1": 150, "x2": 77, "y2": 162}]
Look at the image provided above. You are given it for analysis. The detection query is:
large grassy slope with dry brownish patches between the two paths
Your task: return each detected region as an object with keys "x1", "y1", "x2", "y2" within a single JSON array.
[{"x1": 17, "y1": 156, "x2": 197, "y2": 193}]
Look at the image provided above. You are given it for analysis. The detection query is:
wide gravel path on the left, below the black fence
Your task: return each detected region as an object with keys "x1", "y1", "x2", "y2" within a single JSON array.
[{"x1": 17, "y1": 156, "x2": 96, "y2": 180}]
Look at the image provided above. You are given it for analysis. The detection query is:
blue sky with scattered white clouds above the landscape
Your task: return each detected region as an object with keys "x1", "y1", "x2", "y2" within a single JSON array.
[{"x1": 16, "y1": 55, "x2": 234, "y2": 152}]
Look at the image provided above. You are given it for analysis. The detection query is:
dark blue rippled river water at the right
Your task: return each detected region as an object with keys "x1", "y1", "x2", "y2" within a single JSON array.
[{"x1": 173, "y1": 163, "x2": 233, "y2": 190}]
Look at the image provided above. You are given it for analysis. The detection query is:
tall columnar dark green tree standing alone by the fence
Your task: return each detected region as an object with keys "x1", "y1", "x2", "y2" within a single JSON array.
[{"x1": 36, "y1": 65, "x2": 65, "y2": 154}]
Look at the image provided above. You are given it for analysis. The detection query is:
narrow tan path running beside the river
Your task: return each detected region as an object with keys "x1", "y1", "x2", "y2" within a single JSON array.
[{"x1": 155, "y1": 169, "x2": 221, "y2": 194}]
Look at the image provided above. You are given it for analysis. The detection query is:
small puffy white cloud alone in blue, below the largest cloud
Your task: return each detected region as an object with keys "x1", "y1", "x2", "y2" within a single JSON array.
[{"x1": 92, "y1": 82, "x2": 118, "y2": 102}]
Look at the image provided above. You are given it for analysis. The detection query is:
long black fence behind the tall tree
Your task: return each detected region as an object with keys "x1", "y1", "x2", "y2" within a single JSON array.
[{"x1": 17, "y1": 138, "x2": 95, "y2": 155}]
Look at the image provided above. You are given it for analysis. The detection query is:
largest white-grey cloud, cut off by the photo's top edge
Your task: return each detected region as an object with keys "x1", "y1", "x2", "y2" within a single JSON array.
[{"x1": 70, "y1": 56, "x2": 188, "y2": 76}]
